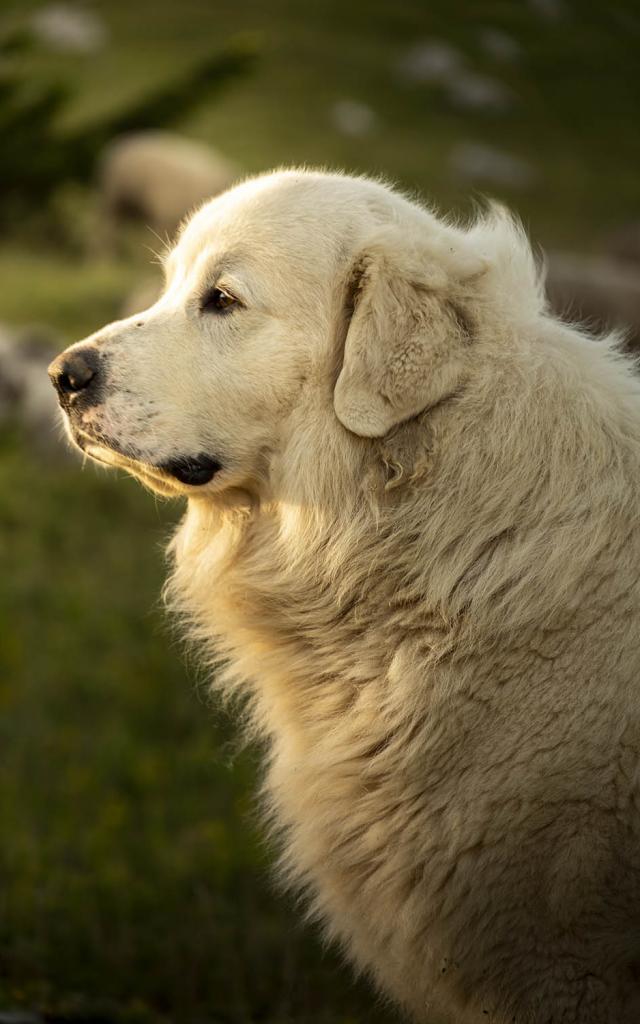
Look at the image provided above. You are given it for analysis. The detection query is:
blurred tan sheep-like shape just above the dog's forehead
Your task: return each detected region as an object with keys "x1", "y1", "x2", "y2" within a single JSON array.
[{"x1": 99, "y1": 131, "x2": 240, "y2": 242}]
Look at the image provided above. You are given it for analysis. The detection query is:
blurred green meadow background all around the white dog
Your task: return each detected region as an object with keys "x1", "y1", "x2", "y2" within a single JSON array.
[{"x1": 0, "y1": 0, "x2": 640, "y2": 1024}]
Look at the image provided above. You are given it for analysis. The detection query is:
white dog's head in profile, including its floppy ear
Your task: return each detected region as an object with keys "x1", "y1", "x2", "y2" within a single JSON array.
[{"x1": 49, "y1": 171, "x2": 499, "y2": 496}]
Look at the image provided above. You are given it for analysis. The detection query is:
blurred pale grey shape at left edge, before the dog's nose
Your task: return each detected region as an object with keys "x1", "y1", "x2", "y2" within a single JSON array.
[{"x1": 0, "y1": 326, "x2": 63, "y2": 454}]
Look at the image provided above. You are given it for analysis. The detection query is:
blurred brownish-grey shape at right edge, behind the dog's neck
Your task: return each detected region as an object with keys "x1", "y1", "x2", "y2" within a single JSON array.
[{"x1": 547, "y1": 252, "x2": 640, "y2": 348}]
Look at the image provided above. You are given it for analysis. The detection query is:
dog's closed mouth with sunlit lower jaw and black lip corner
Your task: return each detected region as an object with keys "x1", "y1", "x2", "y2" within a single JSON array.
[{"x1": 71, "y1": 426, "x2": 222, "y2": 495}]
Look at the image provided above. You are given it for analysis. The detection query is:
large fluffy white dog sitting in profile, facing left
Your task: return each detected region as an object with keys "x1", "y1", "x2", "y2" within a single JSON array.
[{"x1": 51, "y1": 171, "x2": 640, "y2": 1024}]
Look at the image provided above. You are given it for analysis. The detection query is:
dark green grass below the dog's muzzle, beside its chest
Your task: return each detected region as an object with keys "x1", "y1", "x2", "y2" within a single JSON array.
[{"x1": 0, "y1": 436, "x2": 389, "y2": 1024}]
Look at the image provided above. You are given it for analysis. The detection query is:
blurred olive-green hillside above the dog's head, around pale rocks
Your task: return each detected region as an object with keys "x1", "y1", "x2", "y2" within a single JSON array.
[{"x1": 4, "y1": 0, "x2": 640, "y2": 244}]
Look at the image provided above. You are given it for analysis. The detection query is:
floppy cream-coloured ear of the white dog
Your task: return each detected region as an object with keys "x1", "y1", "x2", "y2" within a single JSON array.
[{"x1": 334, "y1": 228, "x2": 484, "y2": 437}]
